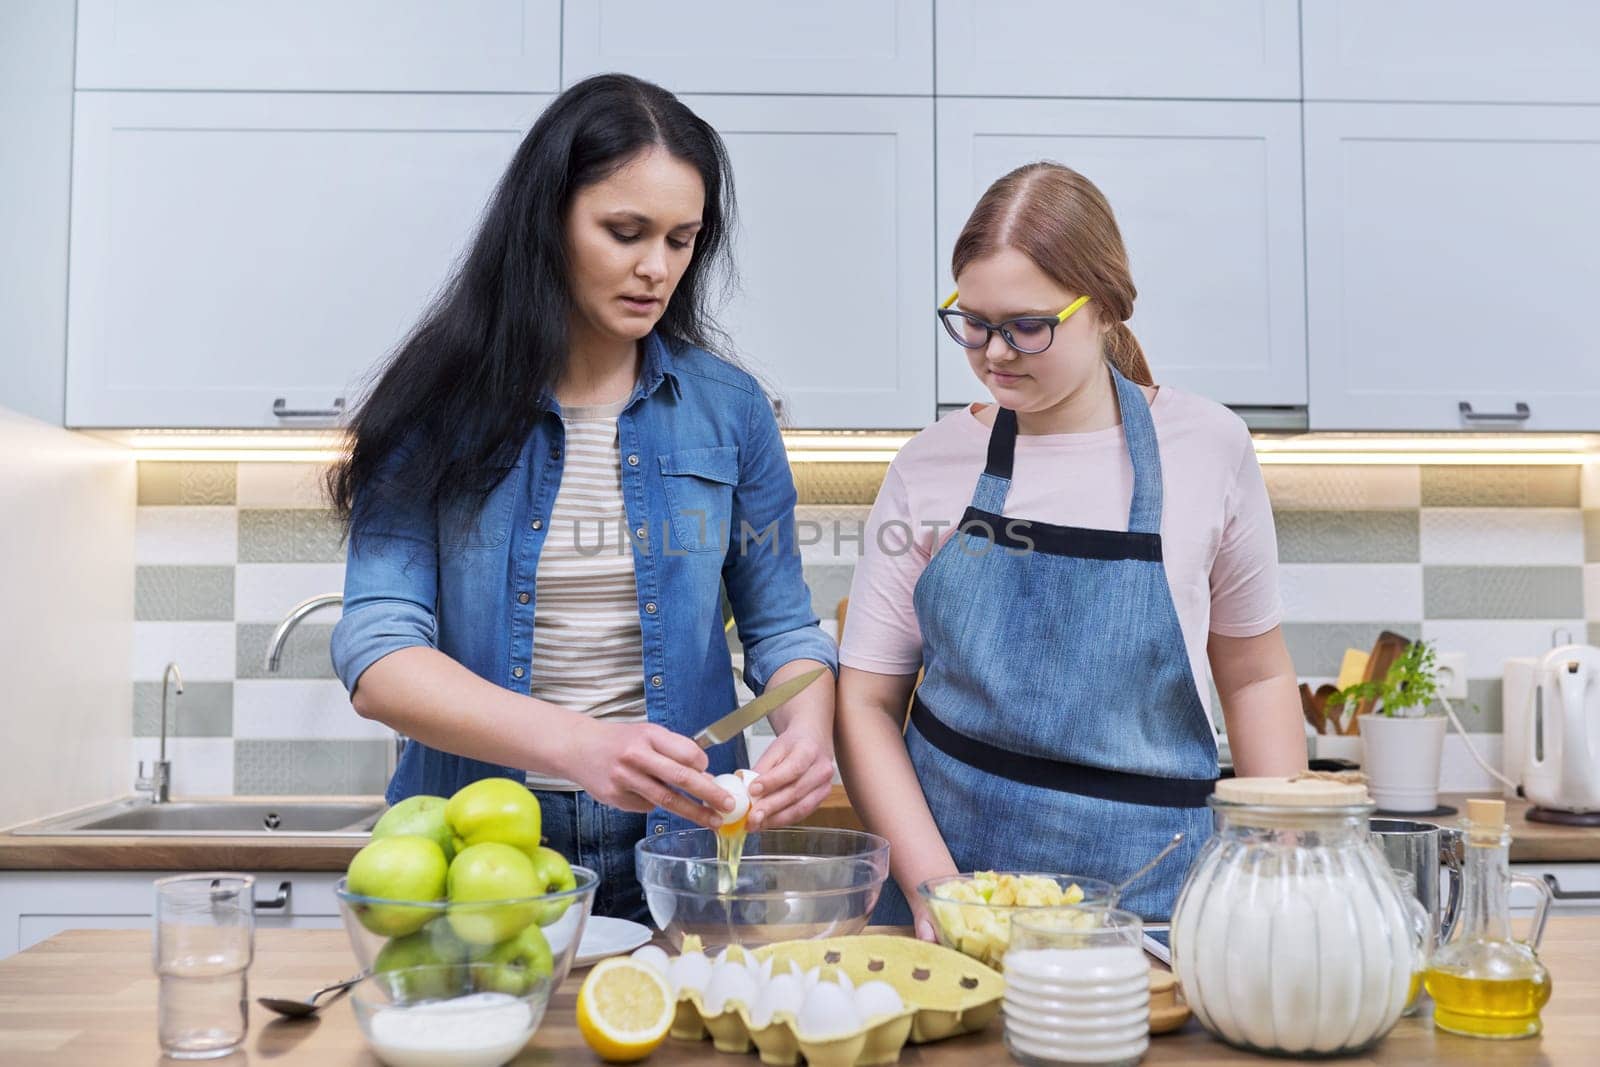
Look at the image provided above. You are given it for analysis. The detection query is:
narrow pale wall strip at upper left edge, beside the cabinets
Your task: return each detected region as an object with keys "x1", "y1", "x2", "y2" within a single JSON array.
[{"x1": 0, "y1": 0, "x2": 75, "y2": 426}]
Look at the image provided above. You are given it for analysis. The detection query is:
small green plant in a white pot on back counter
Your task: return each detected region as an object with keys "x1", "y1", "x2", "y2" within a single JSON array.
[{"x1": 1328, "y1": 641, "x2": 1450, "y2": 813}]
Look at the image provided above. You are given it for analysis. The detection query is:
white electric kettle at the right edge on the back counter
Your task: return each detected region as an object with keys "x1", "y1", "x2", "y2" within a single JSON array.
[{"x1": 1522, "y1": 645, "x2": 1600, "y2": 821}]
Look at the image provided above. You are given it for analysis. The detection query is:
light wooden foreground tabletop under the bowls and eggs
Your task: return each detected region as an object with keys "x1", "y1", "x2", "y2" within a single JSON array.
[{"x1": 0, "y1": 918, "x2": 1600, "y2": 1067}]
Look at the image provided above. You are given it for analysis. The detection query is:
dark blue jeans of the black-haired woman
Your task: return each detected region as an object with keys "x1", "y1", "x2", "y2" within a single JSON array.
[{"x1": 533, "y1": 789, "x2": 650, "y2": 925}]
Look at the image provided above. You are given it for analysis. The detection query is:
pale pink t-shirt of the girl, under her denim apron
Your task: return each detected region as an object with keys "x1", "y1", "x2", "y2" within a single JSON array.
[{"x1": 838, "y1": 386, "x2": 1282, "y2": 726}]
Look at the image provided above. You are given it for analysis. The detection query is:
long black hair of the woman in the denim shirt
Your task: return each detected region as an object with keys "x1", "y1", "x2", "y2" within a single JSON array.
[{"x1": 336, "y1": 74, "x2": 733, "y2": 534}]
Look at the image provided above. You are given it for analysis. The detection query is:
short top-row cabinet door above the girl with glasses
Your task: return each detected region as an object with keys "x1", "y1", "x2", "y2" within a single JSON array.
[{"x1": 936, "y1": 0, "x2": 1299, "y2": 99}]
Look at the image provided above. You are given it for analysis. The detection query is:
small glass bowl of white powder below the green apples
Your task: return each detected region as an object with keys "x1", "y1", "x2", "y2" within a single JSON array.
[{"x1": 350, "y1": 963, "x2": 555, "y2": 1067}]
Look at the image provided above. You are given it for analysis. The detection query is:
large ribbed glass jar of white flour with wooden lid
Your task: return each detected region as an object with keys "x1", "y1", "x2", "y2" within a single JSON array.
[{"x1": 1171, "y1": 777, "x2": 1426, "y2": 1056}]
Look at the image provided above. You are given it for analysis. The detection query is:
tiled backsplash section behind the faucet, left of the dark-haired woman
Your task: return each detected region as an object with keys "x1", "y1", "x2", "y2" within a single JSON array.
[{"x1": 133, "y1": 462, "x2": 392, "y2": 795}]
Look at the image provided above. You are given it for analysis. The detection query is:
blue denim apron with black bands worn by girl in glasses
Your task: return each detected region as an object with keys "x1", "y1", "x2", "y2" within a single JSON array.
[{"x1": 874, "y1": 370, "x2": 1218, "y2": 925}]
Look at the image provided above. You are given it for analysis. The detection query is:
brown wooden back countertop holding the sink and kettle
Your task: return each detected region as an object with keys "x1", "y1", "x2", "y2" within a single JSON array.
[{"x1": 0, "y1": 785, "x2": 1600, "y2": 870}]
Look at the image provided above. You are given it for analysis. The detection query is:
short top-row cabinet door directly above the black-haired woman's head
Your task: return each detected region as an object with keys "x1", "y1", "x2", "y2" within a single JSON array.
[{"x1": 562, "y1": 0, "x2": 933, "y2": 94}]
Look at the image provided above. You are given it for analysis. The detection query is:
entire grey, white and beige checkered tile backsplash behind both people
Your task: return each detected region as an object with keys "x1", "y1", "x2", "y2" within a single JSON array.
[{"x1": 133, "y1": 462, "x2": 1600, "y2": 793}]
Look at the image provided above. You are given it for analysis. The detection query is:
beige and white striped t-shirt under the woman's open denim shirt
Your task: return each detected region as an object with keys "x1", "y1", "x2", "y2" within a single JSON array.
[{"x1": 528, "y1": 402, "x2": 645, "y2": 789}]
